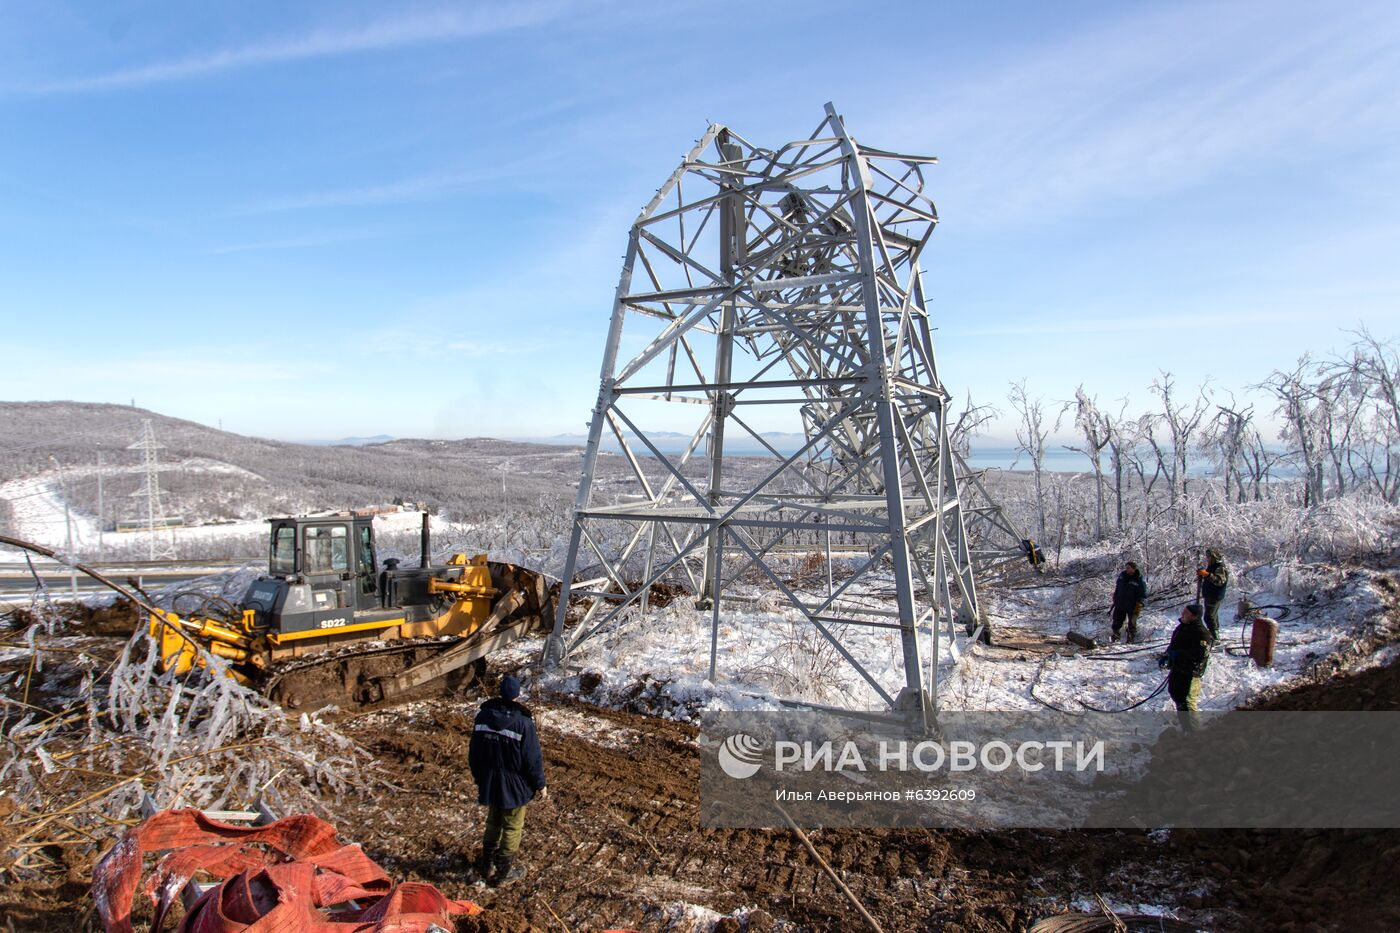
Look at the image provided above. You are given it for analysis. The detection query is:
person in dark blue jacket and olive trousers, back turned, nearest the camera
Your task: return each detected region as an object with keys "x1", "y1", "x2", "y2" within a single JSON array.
[{"x1": 468, "y1": 674, "x2": 549, "y2": 884}]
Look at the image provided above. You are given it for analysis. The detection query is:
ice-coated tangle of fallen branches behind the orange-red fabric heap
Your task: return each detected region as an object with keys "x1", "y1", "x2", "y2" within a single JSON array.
[{"x1": 0, "y1": 613, "x2": 372, "y2": 873}]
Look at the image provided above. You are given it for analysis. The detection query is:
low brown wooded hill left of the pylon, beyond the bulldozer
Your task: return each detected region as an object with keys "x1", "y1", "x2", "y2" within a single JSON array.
[{"x1": 0, "y1": 402, "x2": 596, "y2": 523}]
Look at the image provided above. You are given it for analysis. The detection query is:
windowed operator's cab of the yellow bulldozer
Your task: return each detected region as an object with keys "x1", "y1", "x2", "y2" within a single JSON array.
[{"x1": 267, "y1": 514, "x2": 379, "y2": 609}]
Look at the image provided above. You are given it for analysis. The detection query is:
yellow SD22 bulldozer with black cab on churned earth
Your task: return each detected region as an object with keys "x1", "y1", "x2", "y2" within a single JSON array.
[{"x1": 150, "y1": 513, "x2": 553, "y2": 707}]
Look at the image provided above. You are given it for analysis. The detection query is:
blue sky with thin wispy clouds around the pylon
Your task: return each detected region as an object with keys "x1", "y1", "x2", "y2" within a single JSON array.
[{"x1": 0, "y1": 0, "x2": 1400, "y2": 438}]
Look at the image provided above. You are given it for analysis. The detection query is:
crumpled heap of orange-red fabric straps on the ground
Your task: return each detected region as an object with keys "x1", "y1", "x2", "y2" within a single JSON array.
[{"x1": 92, "y1": 810, "x2": 482, "y2": 933}]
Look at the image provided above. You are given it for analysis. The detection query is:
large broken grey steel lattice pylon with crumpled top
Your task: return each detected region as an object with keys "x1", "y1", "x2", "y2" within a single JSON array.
[{"x1": 546, "y1": 104, "x2": 1021, "y2": 724}]
